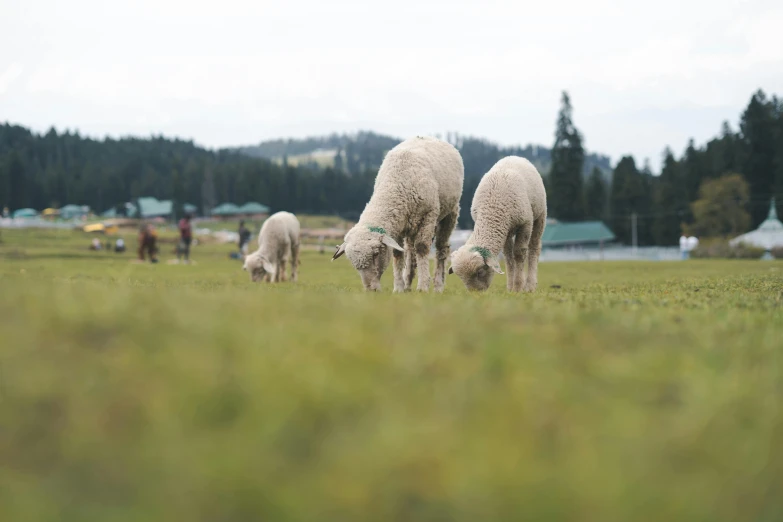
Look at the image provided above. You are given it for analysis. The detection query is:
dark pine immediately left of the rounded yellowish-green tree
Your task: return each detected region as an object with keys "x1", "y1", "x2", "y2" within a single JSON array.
[{"x1": 653, "y1": 148, "x2": 688, "y2": 245}]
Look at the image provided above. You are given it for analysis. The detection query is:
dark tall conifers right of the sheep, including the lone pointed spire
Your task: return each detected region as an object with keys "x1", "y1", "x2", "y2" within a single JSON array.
[{"x1": 546, "y1": 90, "x2": 783, "y2": 245}]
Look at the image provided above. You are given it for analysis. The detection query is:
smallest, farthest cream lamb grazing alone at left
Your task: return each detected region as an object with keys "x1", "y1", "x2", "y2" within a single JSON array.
[{"x1": 242, "y1": 212, "x2": 299, "y2": 283}]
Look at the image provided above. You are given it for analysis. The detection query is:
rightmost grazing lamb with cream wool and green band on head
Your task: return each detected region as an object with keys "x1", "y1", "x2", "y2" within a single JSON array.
[{"x1": 449, "y1": 156, "x2": 547, "y2": 292}]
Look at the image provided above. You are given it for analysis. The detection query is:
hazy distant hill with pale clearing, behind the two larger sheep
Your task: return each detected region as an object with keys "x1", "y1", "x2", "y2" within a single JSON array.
[{"x1": 238, "y1": 131, "x2": 612, "y2": 181}]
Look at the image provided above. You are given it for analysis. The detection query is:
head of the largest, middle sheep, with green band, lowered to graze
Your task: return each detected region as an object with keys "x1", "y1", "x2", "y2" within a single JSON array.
[{"x1": 332, "y1": 224, "x2": 403, "y2": 291}]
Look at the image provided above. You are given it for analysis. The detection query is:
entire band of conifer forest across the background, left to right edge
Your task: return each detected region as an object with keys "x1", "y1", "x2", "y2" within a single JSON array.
[{"x1": 0, "y1": 90, "x2": 783, "y2": 245}]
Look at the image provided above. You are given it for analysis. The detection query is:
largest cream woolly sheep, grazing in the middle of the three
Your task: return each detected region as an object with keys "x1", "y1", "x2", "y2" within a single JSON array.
[{"x1": 332, "y1": 136, "x2": 465, "y2": 293}]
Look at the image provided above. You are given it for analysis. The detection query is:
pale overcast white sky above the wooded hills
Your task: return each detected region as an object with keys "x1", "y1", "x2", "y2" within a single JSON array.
[{"x1": 0, "y1": 0, "x2": 783, "y2": 168}]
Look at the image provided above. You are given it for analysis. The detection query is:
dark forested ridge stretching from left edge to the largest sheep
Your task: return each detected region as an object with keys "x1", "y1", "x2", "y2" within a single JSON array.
[{"x1": 0, "y1": 129, "x2": 375, "y2": 218}]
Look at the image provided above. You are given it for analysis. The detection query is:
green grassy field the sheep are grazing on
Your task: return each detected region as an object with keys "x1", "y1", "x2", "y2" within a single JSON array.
[{"x1": 0, "y1": 231, "x2": 783, "y2": 522}]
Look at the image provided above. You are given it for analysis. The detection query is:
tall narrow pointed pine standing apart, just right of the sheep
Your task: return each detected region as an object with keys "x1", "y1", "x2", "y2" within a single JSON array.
[{"x1": 548, "y1": 92, "x2": 585, "y2": 221}]
